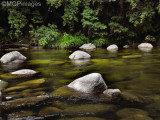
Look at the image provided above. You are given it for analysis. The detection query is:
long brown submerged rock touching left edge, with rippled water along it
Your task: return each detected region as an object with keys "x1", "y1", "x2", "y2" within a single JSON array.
[{"x1": 0, "y1": 96, "x2": 48, "y2": 110}]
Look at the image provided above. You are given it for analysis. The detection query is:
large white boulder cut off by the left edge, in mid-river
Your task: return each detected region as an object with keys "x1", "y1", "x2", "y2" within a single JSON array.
[{"x1": 0, "y1": 51, "x2": 27, "y2": 63}]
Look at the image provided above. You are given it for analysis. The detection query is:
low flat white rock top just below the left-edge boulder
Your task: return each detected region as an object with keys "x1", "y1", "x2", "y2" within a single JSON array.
[{"x1": 11, "y1": 69, "x2": 37, "y2": 75}]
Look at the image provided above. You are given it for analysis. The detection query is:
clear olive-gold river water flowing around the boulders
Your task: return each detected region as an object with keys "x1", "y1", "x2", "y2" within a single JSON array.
[{"x1": 0, "y1": 48, "x2": 160, "y2": 120}]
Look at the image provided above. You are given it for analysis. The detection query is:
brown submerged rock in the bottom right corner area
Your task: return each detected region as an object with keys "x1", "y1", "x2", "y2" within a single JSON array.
[{"x1": 116, "y1": 108, "x2": 148, "y2": 118}]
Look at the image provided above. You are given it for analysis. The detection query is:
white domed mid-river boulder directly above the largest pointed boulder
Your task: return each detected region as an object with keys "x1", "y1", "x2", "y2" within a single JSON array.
[{"x1": 69, "y1": 50, "x2": 91, "y2": 60}]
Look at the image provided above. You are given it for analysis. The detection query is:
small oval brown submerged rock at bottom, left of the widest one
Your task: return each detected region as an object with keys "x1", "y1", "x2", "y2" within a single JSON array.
[{"x1": 38, "y1": 107, "x2": 63, "y2": 117}]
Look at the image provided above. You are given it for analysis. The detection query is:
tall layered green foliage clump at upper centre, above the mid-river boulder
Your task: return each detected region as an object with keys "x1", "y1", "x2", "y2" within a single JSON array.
[{"x1": 81, "y1": 7, "x2": 107, "y2": 38}]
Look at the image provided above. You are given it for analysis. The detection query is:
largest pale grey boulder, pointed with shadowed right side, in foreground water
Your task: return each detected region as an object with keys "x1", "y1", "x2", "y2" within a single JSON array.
[{"x1": 68, "y1": 73, "x2": 107, "y2": 93}]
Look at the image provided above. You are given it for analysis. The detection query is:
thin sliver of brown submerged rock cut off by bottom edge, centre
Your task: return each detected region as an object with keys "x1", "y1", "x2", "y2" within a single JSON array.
[{"x1": 58, "y1": 117, "x2": 106, "y2": 120}]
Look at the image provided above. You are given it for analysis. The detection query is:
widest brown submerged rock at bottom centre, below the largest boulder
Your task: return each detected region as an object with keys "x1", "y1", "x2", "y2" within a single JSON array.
[{"x1": 64, "y1": 104, "x2": 116, "y2": 115}]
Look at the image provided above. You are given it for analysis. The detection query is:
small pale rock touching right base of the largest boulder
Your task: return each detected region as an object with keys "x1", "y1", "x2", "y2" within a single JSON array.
[{"x1": 103, "y1": 89, "x2": 121, "y2": 97}]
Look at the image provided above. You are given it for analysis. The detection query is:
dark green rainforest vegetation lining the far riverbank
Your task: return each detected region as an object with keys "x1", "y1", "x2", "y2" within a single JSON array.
[{"x1": 0, "y1": 0, "x2": 160, "y2": 48}]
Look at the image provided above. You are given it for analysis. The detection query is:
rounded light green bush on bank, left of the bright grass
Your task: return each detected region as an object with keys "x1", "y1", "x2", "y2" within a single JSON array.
[{"x1": 34, "y1": 24, "x2": 60, "y2": 46}]
